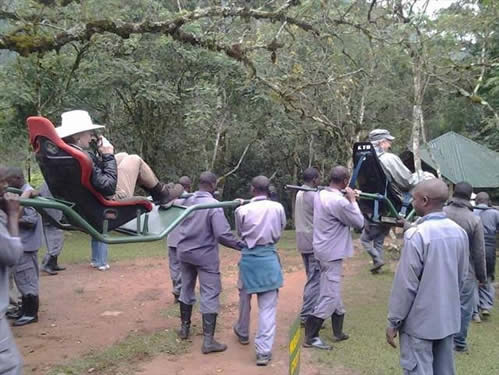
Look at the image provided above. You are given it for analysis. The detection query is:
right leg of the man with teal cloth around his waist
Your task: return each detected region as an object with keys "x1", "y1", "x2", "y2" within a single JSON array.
[{"x1": 255, "y1": 289, "x2": 279, "y2": 366}]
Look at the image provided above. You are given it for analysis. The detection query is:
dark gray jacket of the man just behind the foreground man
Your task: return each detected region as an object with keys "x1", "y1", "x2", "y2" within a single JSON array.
[{"x1": 444, "y1": 197, "x2": 487, "y2": 283}]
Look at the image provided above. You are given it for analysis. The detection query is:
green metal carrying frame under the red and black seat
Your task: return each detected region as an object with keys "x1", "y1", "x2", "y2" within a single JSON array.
[{"x1": 15, "y1": 188, "x2": 249, "y2": 244}]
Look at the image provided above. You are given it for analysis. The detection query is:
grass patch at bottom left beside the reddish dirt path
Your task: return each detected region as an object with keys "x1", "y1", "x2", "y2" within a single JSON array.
[{"x1": 49, "y1": 330, "x2": 188, "y2": 375}]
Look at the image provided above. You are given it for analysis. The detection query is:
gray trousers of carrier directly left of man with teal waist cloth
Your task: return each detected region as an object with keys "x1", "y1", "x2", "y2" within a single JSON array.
[{"x1": 179, "y1": 262, "x2": 222, "y2": 314}]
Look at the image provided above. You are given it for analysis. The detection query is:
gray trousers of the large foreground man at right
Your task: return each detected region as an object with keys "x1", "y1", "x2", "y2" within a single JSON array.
[{"x1": 400, "y1": 332, "x2": 456, "y2": 375}]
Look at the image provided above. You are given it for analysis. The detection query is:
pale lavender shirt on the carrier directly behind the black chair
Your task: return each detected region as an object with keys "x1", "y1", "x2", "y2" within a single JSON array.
[{"x1": 313, "y1": 187, "x2": 364, "y2": 262}]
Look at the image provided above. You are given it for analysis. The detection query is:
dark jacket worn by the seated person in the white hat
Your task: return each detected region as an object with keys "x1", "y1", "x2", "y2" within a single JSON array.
[{"x1": 88, "y1": 152, "x2": 118, "y2": 197}]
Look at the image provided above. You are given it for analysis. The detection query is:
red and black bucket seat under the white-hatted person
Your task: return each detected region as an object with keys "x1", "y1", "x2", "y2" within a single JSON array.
[{"x1": 26, "y1": 117, "x2": 153, "y2": 232}]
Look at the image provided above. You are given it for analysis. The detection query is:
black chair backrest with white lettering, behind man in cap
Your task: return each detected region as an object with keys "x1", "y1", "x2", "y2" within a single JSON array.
[{"x1": 353, "y1": 142, "x2": 402, "y2": 218}]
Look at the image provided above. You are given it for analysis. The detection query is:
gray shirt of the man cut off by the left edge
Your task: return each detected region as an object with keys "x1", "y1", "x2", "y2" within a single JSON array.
[{"x1": 0, "y1": 210, "x2": 23, "y2": 319}]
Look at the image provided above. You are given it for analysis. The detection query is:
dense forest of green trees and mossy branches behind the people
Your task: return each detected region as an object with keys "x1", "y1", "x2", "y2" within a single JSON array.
[{"x1": 0, "y1": 0, "x2": 499, "y2": 222}]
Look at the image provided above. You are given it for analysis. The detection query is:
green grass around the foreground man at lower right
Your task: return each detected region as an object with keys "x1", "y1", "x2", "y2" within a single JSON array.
[{"x1": 313, "y1": 254, "x2": 499, "y2": 375}]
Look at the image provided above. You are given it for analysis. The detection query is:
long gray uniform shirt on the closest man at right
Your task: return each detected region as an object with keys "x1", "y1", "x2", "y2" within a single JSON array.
[{"x1": 388, "y1": 212, "x2": 469, "y2": 340}]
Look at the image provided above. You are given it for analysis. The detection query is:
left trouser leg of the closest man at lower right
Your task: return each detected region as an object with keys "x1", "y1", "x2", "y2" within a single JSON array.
[{"x1": 399, "y1": 332, "x2": 434, "y2": 375}]
